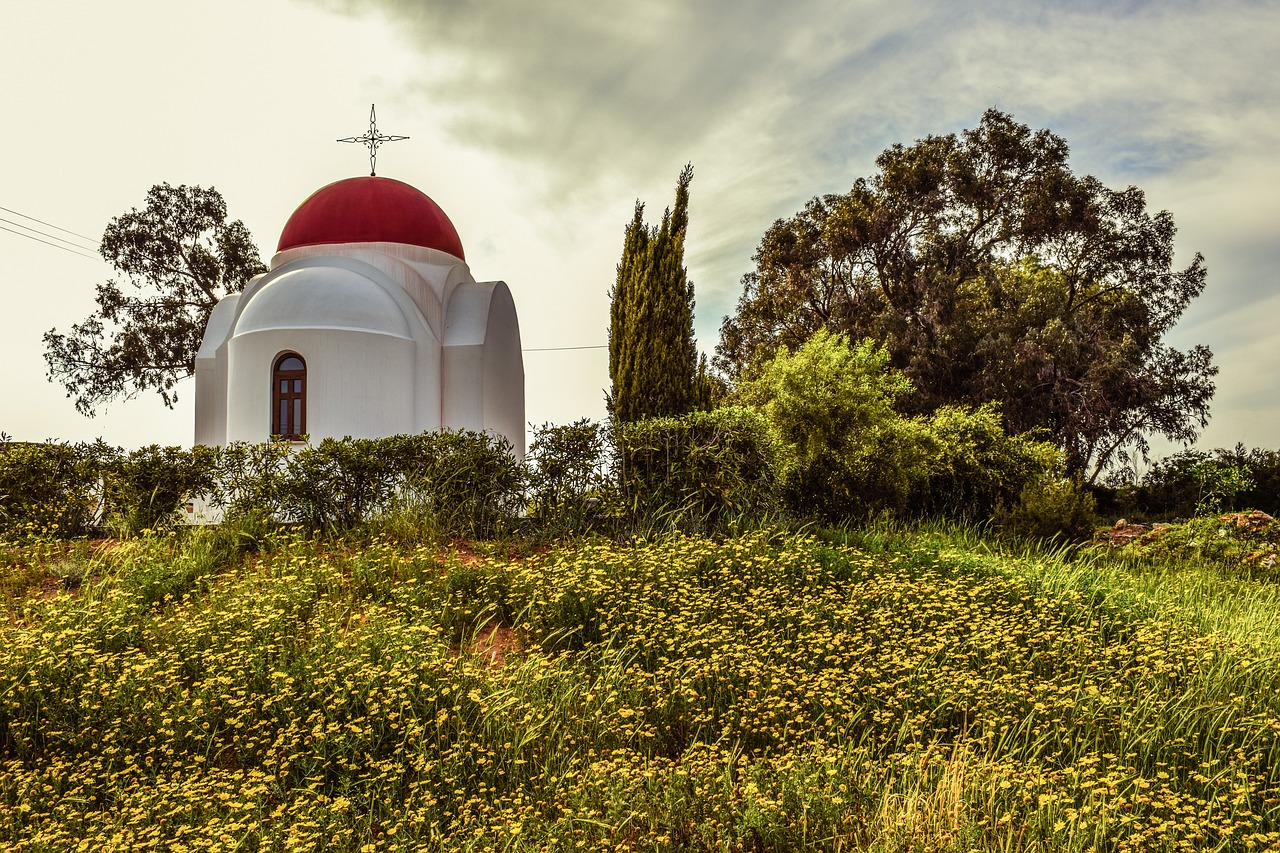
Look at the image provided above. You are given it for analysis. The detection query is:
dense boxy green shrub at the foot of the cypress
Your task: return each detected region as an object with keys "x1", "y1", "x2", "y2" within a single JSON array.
[{"x1": 617, "y1": 406, "x2": 777, "y2": 532}]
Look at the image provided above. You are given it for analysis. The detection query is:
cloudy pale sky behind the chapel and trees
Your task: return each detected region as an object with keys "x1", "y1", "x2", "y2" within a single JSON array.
[{"x1": 0, "y1": 0, "x2": 1280, "y2": 466}]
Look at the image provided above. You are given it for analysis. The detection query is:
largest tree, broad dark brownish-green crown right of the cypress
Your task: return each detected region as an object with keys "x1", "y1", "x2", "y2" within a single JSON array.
[{"x1": 717, "y1": 110, "x2": 1217, "y2": 479}]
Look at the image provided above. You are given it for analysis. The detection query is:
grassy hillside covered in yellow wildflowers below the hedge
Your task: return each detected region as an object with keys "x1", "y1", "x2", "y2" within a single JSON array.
[{"x1": 0, "y1": 532, "x2": 1280, "y2": 850}]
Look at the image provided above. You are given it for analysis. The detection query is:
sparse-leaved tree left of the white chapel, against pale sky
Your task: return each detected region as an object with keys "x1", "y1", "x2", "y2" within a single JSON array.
[{"x1": 45, "y1": 183, "x2": 266, "y2": 418}]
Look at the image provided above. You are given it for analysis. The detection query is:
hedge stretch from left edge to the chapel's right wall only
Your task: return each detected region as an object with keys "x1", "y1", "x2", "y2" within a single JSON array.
[{"x1": 0, "y1": 432, "x2": 525, "y2": 538}]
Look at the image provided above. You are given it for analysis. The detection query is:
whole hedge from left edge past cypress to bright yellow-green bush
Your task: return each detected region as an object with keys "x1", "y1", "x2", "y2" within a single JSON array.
[{"x1": 0, "y1": 409, "x2": 774, "y2": 539}]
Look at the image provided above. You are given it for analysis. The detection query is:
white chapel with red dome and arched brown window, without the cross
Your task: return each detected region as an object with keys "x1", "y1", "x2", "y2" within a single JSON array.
[{"x1": 188, "y1": 175, "x2": 525, "y2": 456}]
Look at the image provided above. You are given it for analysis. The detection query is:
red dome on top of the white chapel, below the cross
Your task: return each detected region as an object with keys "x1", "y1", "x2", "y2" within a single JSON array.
[{"x1": 275, "y1": 175, "x2": 466, "y2": 260}]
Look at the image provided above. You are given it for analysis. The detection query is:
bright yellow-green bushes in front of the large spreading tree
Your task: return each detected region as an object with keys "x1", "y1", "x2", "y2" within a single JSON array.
[{"x1": 737, "y1": 329, "x2": 1061, "y2": 523}]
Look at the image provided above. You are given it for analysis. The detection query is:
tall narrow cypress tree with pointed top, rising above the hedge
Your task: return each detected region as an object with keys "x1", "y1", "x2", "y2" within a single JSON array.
[{"x1": 608, "y1": 165, "x2": 709, "y2": 423}]
